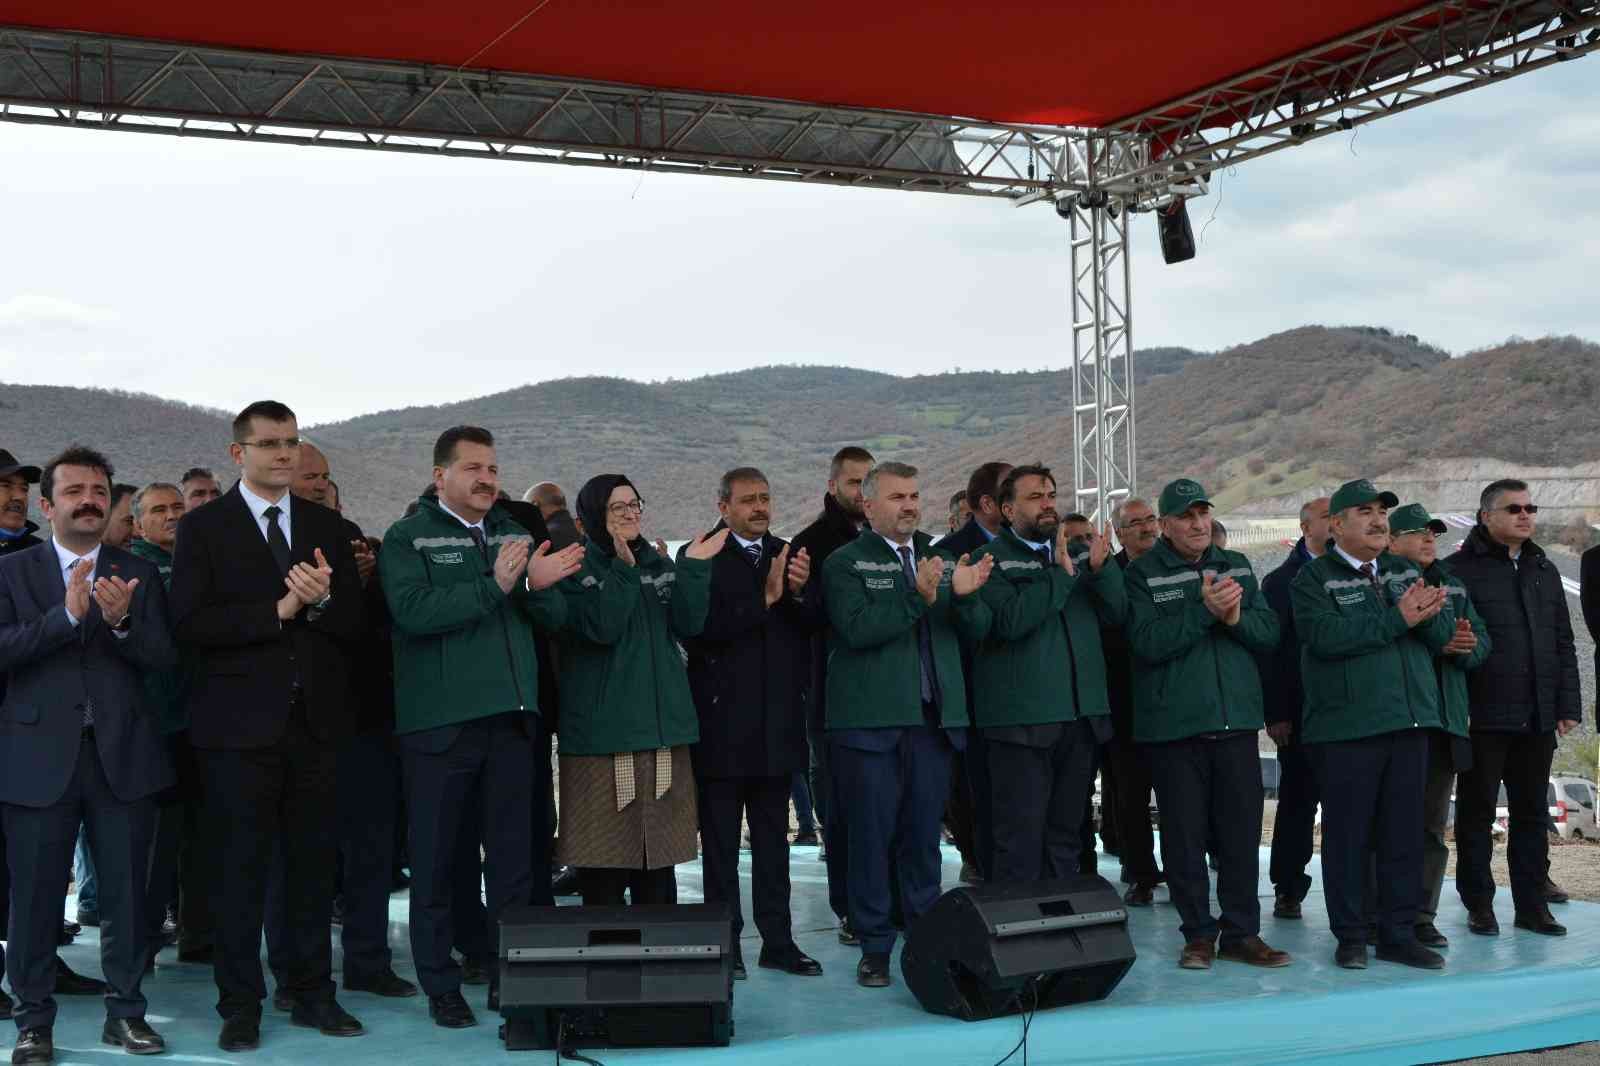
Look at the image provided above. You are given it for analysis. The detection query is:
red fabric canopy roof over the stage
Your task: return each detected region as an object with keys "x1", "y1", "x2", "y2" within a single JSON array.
[{"x1": 0, "y1": 0, "x2": 1446, "y2": 126}]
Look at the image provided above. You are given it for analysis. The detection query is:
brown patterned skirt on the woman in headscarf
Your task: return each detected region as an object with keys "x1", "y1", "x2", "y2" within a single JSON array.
[{"x1": 555, "y1": 744, "x2": 699, "y2": 869}]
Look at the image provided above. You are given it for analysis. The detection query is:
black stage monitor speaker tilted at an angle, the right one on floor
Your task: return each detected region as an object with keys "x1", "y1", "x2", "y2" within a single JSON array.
[{"x1": 901, "y1": 874, "x2": 1134, "y2": 1021}]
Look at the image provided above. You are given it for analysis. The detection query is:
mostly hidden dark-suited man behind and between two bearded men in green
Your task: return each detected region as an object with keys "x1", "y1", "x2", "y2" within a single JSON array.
[{"x1": 939, "y1": 461, "x2": 1011, "y2": 882}]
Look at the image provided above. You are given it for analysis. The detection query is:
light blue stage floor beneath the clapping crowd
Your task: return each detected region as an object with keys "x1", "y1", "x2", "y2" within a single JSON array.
[{"x1": 43, "y1": 848, "x2": 1600, "y2": 1066}]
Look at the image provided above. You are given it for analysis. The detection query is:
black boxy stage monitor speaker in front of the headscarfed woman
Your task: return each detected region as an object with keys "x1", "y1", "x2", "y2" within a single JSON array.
[{"x1": 498, "y1": 903, "x2": 733, "y2": 1050}]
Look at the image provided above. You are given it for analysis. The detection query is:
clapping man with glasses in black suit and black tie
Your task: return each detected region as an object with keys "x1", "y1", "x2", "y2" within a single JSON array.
[{"x1": 171, "y1": 400, "x2": 365, "y2": 1052}]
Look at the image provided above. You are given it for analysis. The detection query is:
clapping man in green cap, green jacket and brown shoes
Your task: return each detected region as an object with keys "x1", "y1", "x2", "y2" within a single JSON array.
[{"x1": 1128, "y1": 477, "x2": 1290, "y2": 970}]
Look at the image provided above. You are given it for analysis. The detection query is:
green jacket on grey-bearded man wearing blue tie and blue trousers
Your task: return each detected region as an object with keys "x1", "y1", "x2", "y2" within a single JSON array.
[{"x1": 822, "y1": 528, "x2": 984, "y2": 730}]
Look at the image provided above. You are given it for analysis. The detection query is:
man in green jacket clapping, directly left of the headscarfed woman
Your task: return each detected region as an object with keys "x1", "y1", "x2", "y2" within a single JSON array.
[{"x1": 379, "y1": 426, "x2": 582, "y2": 1029}]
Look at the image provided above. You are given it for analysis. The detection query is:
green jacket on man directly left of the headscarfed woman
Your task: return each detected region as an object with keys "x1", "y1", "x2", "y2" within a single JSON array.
[{"x1": 378, "y1": 496, "x2": 566, "y2": 733}]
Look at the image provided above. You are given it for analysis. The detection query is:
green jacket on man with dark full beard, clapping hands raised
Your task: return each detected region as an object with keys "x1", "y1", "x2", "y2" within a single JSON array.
[{"x1": 973, "y1": 528, "x2": 1128, "y2": 727}]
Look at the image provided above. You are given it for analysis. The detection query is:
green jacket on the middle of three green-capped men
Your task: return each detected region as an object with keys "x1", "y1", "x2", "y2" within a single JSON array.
[{"x1": 1290, "y1": 546, "x2": 1456, "y2": 744}]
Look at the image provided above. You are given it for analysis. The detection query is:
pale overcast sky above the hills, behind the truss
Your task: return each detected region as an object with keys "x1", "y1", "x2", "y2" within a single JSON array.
[{"x1": 0, "y1": 58, "x2": 1600, "y2": 424}]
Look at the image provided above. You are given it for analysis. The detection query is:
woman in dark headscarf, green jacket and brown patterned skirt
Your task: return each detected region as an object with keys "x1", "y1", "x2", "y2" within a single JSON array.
[{"x1": 558, "y1": 474, "x2": 728, "y2": 906}]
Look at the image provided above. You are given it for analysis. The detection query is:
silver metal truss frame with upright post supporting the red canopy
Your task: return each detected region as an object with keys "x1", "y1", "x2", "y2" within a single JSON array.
[{"x1": 0, "y1": 0, "x2": 1600, "y2": 520}]
